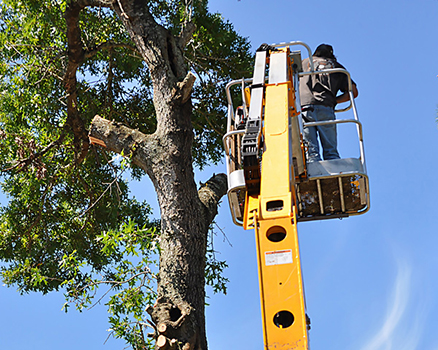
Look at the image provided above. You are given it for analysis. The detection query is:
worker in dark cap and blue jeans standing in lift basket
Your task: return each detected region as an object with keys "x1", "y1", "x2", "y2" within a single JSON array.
[{"x1": 300, "y1": 44, "x2": 359, "y2": 162}]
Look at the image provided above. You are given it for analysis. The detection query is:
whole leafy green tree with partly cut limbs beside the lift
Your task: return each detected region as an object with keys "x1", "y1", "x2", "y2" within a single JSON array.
[{"x1": 0, "y1": 0, "x2": 252, "y2": 350}]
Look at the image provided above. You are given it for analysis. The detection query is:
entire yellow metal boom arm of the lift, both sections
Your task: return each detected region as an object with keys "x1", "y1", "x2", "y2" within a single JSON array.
[{"x1": 243, "y1": 47, "x2": 308, "y2": 350}]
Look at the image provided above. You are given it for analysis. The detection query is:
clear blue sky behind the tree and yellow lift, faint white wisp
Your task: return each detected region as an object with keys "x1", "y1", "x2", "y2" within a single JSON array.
[{"x1": 0, "y1": 0, "x2": 438, "y2": 350}]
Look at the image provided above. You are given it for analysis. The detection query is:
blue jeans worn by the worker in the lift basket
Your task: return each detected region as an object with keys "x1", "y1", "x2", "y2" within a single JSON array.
[{"x1": 301, "y1": 105, "x2": 340, "y2": 162}]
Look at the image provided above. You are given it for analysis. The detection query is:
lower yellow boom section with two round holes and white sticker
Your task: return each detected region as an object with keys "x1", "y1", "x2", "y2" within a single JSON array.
[{"x1": 256, "y1": 209, "x2": 308, "y2": 350}]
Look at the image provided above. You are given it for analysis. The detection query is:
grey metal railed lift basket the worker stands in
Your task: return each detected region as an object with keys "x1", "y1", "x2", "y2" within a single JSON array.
[{"x1": 223, "y1": 41, "x2": 370, "y2": 226}]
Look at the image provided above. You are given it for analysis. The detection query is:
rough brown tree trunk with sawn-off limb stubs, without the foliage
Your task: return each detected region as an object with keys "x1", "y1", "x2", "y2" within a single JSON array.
[{"x1": 89, "y1": 0, "x2": 227, "y2": 350}]
